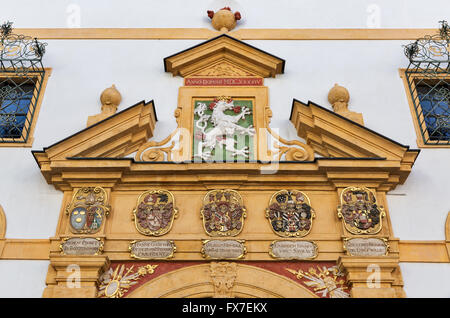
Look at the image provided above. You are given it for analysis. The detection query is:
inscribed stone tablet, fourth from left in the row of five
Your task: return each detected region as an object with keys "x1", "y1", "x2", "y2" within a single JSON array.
[{"x1": 269, "y1": 241, "x2": 317, "y2": 259}]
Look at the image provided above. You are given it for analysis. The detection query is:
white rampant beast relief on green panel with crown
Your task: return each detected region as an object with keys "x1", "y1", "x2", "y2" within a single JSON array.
[{"x1": 193, "y1": 96, "x2": 255, "y2": 162}]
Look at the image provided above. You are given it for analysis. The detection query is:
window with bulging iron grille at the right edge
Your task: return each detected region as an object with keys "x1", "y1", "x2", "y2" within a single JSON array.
[{"x1": 403, "y1": 21, "x2": 450, "y2": 147}]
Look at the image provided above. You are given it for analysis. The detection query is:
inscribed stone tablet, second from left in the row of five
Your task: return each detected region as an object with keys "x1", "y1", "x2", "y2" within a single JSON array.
[{"x1": 130, "y1": 240, "x2": 176, "y2": 259}]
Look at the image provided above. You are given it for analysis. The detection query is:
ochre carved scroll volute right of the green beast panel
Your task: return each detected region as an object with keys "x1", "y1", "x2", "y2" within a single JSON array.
[{"x1": 265, "y1": 107, "x2": 314, "y2": 161}]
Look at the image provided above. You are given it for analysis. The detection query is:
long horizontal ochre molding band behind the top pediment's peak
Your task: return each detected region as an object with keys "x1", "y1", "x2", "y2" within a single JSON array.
[{"x1": 15, "y1": 28, "x2": 437, "y2": 40}]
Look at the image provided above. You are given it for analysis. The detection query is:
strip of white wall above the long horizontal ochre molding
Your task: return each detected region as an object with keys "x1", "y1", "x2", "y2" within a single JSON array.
[{"x1": 1, "y1": 0, "x2": 449, "y2": 28}]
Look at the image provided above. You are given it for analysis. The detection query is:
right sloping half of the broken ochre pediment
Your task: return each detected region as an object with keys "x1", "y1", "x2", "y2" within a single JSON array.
[{"x1": 290, "y1": 99, "x2": 419, "y2": 176}]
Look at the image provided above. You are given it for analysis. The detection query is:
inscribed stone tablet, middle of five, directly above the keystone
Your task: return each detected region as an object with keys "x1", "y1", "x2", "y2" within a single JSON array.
[{"x1": 201, "y1": 240, "x2": 247, "y2": 259}]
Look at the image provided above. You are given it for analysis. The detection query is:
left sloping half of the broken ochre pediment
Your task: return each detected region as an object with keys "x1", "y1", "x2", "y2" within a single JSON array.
[{"x1": 32, "y1": 101, "x2": 156, "y2": 179}]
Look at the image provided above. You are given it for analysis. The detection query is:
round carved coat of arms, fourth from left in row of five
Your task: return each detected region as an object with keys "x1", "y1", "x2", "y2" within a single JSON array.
[{"x1": 266, "y1": 190, "x2": 315, "y2": 237}]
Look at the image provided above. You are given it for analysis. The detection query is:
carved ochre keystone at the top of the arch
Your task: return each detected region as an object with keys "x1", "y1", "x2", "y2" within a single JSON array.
[{"x1": 209, "y1": 262, "x2": 237, "y2": 298}]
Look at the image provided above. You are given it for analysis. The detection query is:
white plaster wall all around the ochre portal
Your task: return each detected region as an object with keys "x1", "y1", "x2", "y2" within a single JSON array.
[{"x1": 0, "y1": 0, "x2": 450, "y2": 297}]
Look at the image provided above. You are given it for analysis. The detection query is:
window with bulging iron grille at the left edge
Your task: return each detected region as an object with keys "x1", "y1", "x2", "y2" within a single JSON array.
[{"x1": 0, "y1": 22, "x2": 47, "y2": 146}]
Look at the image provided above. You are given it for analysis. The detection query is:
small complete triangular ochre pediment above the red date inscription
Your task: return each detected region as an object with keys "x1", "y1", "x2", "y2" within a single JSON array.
[{"x1": 164, "y1": 34, "x2": 285, "y2": 77}]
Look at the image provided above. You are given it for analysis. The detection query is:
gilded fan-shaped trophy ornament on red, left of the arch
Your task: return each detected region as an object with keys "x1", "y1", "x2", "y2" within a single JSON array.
[{"x1": 98, "y1": 264, "x2": 158, "y2": 298}]
